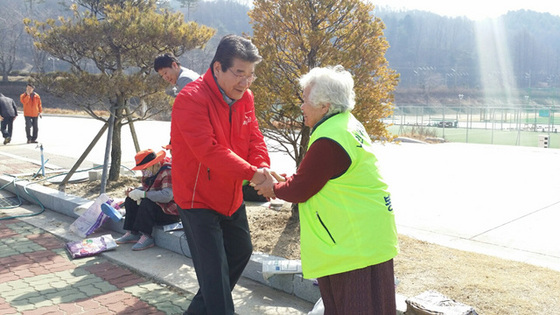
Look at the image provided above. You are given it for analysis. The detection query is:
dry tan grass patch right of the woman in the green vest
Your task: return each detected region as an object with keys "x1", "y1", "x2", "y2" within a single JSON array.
[{"x1": 395, "y1": 235, "x2": 560, "y2": 315}]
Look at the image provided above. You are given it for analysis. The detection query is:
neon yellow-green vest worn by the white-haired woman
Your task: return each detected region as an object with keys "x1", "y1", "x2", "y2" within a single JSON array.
[{"x1": 299, "y1": 112, "x2": 398, "y2": 278}]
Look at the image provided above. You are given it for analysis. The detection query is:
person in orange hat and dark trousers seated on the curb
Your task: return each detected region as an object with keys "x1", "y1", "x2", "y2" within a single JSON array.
[{"x1": 116, "y1": 149, "x2": 179, "y2": 250}]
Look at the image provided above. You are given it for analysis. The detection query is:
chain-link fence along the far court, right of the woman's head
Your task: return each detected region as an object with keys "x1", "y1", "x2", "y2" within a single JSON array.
[{"x1": 384, "y1": 105, "x2": 560, "y2": 148}]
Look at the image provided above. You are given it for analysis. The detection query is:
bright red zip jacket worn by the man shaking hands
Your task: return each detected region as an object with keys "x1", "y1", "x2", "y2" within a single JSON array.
[{"x1": 171, "y1": 69, "x2": 270, "y2": 216}]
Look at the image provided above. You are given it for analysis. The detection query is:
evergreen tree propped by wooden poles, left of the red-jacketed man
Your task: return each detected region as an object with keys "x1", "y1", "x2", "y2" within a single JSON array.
[{"x1": 25, "y1": 0, "x2": 214, "y2": 181}]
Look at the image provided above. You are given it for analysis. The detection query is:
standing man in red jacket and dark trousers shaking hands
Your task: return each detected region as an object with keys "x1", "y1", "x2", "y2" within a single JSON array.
[{"x1": 171, "y1": 35, "x2": 270, "y2": 315}]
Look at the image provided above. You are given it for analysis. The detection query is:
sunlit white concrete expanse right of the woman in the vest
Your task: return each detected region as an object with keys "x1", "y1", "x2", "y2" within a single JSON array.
[{"x1": 377, "y1": 143, "x2": 560, "y2": 271}]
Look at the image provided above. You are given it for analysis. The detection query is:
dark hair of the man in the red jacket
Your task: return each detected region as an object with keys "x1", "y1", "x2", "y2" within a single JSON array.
[{"x1": 210, "y1": 34, "x2": 262, "y2": 71}]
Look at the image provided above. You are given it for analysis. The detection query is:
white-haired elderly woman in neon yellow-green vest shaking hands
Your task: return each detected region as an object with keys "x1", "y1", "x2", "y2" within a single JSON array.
[{"x1": 255, "y1": 66, "x2": 398, "y2": 315}]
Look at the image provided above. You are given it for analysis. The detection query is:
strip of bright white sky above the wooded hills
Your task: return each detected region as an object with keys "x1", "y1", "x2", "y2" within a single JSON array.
[{"x1": 370, "y1": 0, "x2": 560, "y2": 20}]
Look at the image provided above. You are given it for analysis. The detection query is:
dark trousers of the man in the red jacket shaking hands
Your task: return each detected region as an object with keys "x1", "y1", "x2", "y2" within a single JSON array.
[{"x1": 179, "y1": 204, "x2": 253, "y2": 315}]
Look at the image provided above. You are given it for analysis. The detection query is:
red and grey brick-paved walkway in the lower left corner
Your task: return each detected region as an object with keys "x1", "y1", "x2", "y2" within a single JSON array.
[{"x1": 0, "y1": 219, "x2": 192, "y2": 315}]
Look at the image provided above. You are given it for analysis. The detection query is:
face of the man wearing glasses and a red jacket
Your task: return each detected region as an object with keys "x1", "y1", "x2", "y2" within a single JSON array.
[{"x1": 214, "y1": 58, "x2": 256, "y2": 100}]
